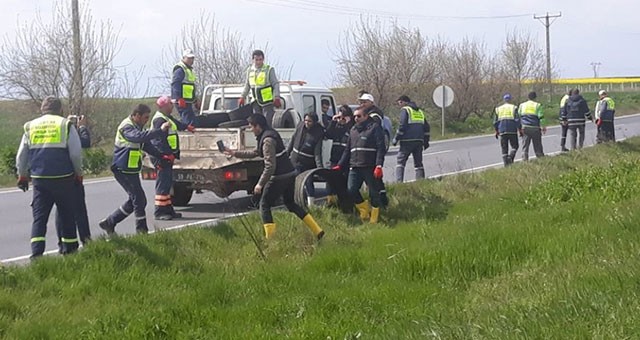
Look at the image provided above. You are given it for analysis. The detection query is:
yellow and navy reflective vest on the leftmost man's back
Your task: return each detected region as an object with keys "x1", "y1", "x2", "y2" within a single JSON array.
[{"x1": 24, "y1": 114, "x2": 74, "y2": 178}]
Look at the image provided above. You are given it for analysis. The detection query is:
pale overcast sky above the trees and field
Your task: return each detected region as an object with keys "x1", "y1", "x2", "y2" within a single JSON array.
[{"x1": 5, "y1": 0, "x2": 640, "y2": 94}]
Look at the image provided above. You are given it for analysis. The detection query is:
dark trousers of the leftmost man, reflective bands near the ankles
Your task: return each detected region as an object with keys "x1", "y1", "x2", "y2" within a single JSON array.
[{"x1": 31, "y1": 176, "x2": 79, "y2": 257}]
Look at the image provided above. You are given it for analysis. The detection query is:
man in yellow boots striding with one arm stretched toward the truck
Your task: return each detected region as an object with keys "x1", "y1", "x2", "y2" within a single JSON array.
[{"x1": 224, "y1": 114, "x2": 324, "y2": 240}]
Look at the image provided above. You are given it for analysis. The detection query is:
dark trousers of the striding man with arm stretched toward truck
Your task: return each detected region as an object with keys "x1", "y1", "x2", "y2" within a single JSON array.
[{"x1": 260, "y1": 176, "x2": 307, "y2": 224}]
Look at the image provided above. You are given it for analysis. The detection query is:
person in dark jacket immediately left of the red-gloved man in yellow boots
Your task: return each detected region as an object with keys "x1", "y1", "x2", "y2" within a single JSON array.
[{"x1": 325, "y1": 105, "x2": 354, "y2": 205}]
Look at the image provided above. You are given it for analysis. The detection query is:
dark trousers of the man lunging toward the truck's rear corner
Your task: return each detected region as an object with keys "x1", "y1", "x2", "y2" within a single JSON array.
[{"x1": 107, "y1": 167, "x2": 149, "y2": 231}]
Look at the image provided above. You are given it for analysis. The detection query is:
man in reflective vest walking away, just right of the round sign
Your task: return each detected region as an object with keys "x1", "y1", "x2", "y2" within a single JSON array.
[{"x1": 493, "y1": 93, "x2": 522, "y2": 167}]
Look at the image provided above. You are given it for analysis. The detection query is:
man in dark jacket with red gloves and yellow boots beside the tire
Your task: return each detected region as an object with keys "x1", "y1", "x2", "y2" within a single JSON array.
[{"x1": 332, "y1": 109, "x2": 386, "y2": 223}]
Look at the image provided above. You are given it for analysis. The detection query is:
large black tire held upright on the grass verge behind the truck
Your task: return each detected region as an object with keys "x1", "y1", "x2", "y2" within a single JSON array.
[{"x1": 293, "y1": 168, "x2": 354, "y2": 214}]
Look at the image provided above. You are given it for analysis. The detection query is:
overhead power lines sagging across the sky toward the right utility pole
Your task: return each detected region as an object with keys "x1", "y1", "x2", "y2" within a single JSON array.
[{"x1": 247, "y1": 0, "x2": 531, "y2": 20}]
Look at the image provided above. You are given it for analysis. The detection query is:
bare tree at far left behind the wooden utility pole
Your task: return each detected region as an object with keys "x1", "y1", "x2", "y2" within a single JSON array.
[{"x1": 0, "y1": 1, "x2": 120, "y2": 106}]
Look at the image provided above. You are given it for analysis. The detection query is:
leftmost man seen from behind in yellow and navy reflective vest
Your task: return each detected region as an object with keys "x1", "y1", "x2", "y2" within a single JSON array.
[{"x1": 16, "y1": 96, "x2": 83, "y2": 259}]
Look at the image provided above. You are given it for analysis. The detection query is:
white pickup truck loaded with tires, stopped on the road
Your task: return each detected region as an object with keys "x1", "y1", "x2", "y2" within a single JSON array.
[{"x1": 142, "y1": 82, "x2": 336, "y2": 206}]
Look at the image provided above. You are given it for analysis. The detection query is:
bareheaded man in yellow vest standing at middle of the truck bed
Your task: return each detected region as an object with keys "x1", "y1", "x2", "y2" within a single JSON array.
[{"x1": 238, "y1": 50, "x2": 281, "y2": 126}]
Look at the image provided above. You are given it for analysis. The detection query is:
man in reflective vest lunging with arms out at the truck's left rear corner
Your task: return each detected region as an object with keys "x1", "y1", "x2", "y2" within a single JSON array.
[{"x1": 99, "y1": 104, "x2": 175, "y2": 235}]
